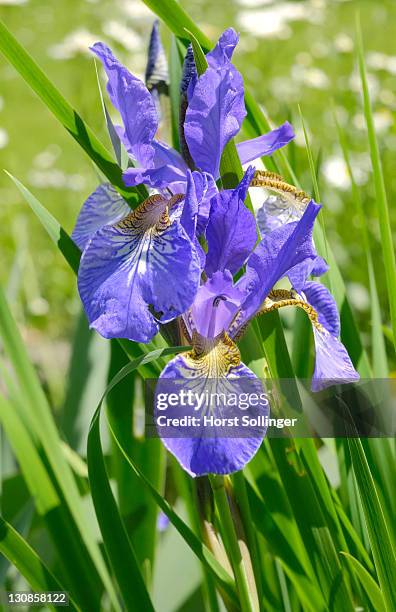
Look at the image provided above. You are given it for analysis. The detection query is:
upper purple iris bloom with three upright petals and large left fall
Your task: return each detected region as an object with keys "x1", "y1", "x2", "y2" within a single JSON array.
[{"x1": 72, "y1": 25, "x2": 294, "y2": 342}]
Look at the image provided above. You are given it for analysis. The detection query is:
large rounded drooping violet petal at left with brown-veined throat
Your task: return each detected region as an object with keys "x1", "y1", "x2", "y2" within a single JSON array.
[{"x1": 78, "y1": 196, "x2": 200, "y2": 342}]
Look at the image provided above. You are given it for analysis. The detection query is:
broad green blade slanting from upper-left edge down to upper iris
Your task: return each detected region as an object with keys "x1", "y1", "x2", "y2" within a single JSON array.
[{"x1": 0, "y1": 21, "x2": 148, "y2": 208}]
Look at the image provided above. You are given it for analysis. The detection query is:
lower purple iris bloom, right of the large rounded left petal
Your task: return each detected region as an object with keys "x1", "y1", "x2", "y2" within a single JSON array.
[{"x1": 160, "y1": 168, "x2": 358, "y2": 476}]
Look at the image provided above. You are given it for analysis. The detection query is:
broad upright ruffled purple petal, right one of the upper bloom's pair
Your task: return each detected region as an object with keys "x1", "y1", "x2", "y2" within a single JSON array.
[{"x1": 184, "y1": 64, "x2": 246, "y2": 179}]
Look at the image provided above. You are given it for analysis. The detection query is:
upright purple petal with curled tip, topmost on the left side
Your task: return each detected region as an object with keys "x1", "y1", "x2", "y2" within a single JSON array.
[{"x1": 91, "y1": 43, "x2": 158, "y2": 166}]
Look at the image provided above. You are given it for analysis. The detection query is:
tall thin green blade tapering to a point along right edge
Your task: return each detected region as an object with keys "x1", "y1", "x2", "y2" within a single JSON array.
[{"x1": 356, "y1": 18, "x2": 396, "y2": 348}]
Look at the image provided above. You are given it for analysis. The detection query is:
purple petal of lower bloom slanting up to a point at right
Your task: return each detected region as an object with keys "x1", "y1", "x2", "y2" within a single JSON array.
[{"x1": 237, "y1": 200, "x2": 321, "y2": 325}]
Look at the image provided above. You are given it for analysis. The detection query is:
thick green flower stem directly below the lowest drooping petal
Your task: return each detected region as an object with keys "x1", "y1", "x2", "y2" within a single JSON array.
[{"x1": 209, "y1": 474, "x2": 257, "y2": 612}]
